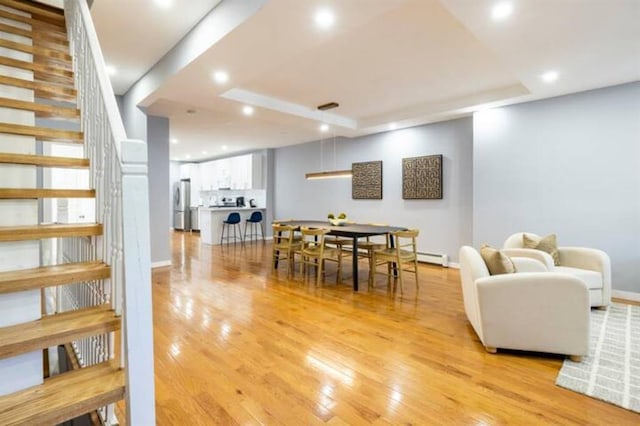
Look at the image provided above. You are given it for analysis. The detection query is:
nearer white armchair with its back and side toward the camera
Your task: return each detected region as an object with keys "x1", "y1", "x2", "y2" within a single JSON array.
[{"x1": 460, "y1": 246, "x2": 590, "y2": 360}]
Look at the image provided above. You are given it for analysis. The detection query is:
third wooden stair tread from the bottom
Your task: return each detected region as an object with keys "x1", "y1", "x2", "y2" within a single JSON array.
[{"x1": 0, "y1": 261, "x2": 111, "y2": 294}]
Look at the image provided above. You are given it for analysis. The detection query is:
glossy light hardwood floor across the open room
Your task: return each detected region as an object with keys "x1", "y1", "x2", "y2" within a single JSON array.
[{"x1": 153, "y1": 233, "x2": 640, "y2": 425}]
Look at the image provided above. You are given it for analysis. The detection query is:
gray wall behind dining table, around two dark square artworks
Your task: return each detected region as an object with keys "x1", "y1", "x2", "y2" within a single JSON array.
[{"x1": 273, "y1": 118, "x2": 473, "y2": 261}]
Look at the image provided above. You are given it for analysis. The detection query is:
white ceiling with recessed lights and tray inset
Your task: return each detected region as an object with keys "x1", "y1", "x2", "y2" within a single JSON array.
[{"x1": 92, "y1": 0, "x2": 640, "y2": 161}]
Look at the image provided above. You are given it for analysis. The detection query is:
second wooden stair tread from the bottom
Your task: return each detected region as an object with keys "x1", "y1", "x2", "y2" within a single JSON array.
[{"x1": 0, "y1": 305, "x2": 120, "y2": 359}]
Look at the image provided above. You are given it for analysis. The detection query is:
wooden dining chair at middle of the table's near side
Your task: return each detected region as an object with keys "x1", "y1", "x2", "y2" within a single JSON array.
[{"x1": 300, "y1": 227, "x2": 342, "y2": 285}]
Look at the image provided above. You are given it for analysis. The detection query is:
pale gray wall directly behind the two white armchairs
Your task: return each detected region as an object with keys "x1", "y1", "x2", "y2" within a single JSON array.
[{"x1": 473, "y1": 82, "x2": 640, "y2": 292}]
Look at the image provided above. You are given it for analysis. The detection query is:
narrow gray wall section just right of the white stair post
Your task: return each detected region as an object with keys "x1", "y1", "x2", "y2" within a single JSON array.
[{"x1": 147, "y1": 115, "x2": 171, "y2": 263}]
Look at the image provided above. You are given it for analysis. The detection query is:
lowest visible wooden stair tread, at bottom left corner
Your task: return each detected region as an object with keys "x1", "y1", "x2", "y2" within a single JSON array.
[{"x1": 0, "y1": 362, "x2": 125, "y2": 426}]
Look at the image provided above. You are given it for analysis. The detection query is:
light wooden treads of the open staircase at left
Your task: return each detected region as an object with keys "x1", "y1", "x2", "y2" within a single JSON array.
[{"x1": 0, "y1": 0, "x2": 125, "y2": 425}]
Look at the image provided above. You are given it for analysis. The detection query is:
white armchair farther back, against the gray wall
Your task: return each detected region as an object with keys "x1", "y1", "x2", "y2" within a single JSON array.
[{"x1": 503, "y1": 232, "x2": 611, "y2": 308}]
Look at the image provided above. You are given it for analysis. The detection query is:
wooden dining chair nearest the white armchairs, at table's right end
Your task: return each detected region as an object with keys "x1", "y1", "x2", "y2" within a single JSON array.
[{"x1": 369, "y1": 229, "x2": 420, "y2": 294}]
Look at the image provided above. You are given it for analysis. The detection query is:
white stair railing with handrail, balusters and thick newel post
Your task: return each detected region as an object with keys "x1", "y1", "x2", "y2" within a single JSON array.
[{"x1": 64, "y1": 0, "x2": 155, "y2": 425}]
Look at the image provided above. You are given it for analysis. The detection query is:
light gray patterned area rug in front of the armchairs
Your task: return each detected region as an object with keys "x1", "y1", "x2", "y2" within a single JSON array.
[{"x1": 556, "y1": 303, "x2": 640, "y2": 413}]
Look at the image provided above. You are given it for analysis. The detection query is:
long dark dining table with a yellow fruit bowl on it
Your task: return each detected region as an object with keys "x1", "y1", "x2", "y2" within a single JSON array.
[{"x1": 278, "y1": 220, "x2": 407, "y2": 291}]
